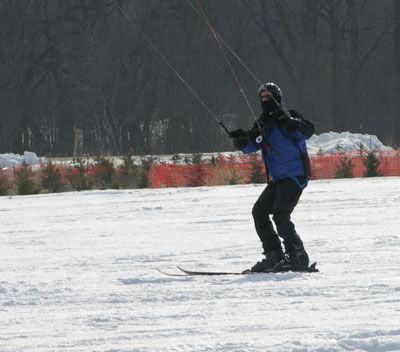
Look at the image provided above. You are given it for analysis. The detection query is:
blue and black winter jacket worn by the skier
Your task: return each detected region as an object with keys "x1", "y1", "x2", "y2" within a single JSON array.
[{"x1": 242, "y1": 110, "x2": 314, "y2": 188}]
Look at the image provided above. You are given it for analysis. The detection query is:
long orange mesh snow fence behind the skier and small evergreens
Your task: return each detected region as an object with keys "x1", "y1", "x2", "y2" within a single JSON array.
[{"x1": 0, "y1": 150, "x2": 400, "y2": 195}]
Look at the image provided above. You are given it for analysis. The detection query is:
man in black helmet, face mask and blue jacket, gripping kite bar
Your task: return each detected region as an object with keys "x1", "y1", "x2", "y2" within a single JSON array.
[{"x1": 230, "y1": 83, "x2": 314, "y2": 272}]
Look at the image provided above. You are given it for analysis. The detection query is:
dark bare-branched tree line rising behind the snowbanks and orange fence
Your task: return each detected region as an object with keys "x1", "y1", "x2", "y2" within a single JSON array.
[{"x1": 0, "y1": 0, "x2": 400, "y2": 156}]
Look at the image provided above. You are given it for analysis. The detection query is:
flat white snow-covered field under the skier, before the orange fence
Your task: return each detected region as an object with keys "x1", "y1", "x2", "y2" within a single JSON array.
[{"x1": 0, "y1": 178, "x2": 400, "y2": 352}]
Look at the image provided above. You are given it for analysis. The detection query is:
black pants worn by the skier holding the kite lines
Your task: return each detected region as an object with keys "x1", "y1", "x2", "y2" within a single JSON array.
[{"x1": 253, "y1": 178, "x2": 303, "y2": 251}]
